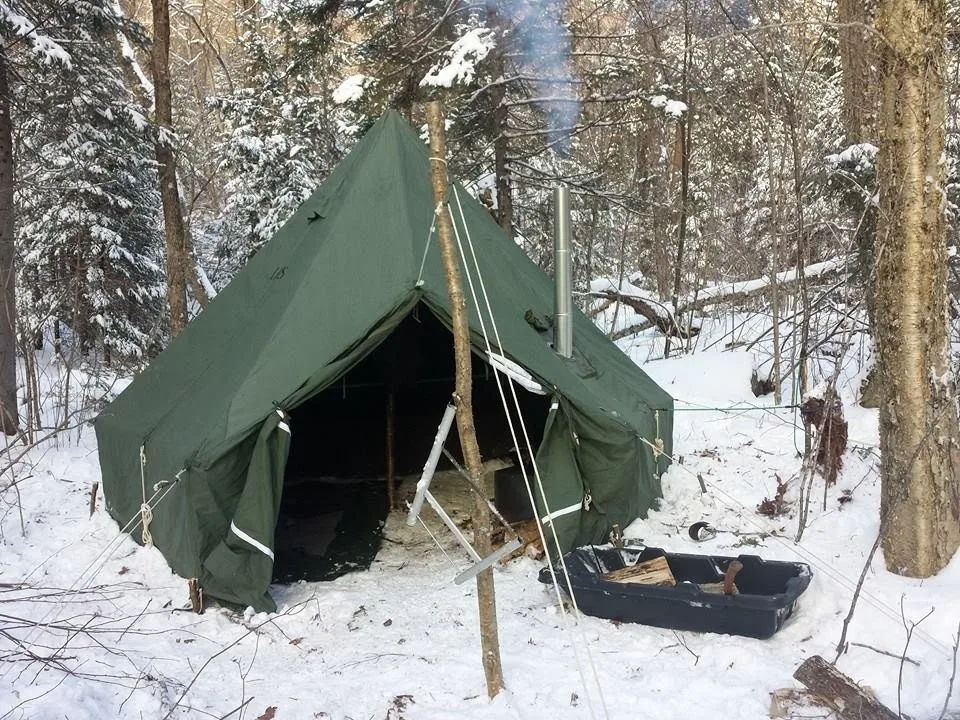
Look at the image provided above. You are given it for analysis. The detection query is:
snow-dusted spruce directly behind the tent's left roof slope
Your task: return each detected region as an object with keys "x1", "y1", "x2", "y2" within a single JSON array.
[{"x1": 202, "y1": 0, "x2": 342, "y2": 286}]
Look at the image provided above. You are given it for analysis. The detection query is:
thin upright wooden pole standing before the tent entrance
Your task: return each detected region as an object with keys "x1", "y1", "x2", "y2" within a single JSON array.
[{"x1": 427, "y1": 102, "x2": 503, "y2": 698}]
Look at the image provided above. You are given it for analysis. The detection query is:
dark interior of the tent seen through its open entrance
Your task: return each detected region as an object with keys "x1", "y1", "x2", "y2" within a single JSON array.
[{"x1": 274, "y1": 305, "x2": 550, "y2": 582}]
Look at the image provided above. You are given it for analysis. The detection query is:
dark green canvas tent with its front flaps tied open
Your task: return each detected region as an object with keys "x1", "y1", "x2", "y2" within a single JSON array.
[{"x1": 96, "y1": 112, "x2": 673, "y2": 610}]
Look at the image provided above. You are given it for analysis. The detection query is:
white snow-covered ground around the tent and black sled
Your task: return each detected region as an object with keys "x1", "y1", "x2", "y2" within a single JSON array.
[{"x1": 0, "y1": 334, "x2": 960, "y2": 720}]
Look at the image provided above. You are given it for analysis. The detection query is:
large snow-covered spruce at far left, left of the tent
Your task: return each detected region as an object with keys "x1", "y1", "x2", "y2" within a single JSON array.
[{"x1": 14, "y1": 0, "x2": 163, "y2": 362}]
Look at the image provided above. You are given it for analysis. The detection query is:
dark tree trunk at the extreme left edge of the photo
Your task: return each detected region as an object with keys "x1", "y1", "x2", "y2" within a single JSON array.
[{"x1": 0, "y1": 47, "x2": 20, "y2": 435}]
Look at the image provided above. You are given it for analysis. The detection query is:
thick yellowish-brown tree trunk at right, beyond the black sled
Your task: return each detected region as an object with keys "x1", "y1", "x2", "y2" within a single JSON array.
[{"x1": 875, "y1": 0, "x2": 960, "y2": 577}]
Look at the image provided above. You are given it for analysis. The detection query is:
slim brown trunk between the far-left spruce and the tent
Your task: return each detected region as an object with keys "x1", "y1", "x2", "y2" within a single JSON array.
[{"x1": 150, "y1": 0, "x2": 188, "y2": 336}]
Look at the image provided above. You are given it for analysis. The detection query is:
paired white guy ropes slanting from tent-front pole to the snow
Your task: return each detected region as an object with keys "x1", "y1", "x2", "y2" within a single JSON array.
[{"x1": 448, "y1": 185, "x2": 610, "y2": 718}]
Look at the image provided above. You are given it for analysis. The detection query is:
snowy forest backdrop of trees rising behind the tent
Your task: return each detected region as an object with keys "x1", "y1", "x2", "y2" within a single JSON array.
[{"x1": 3, "y1": 0, "x2": 960, "y2": 367}]
